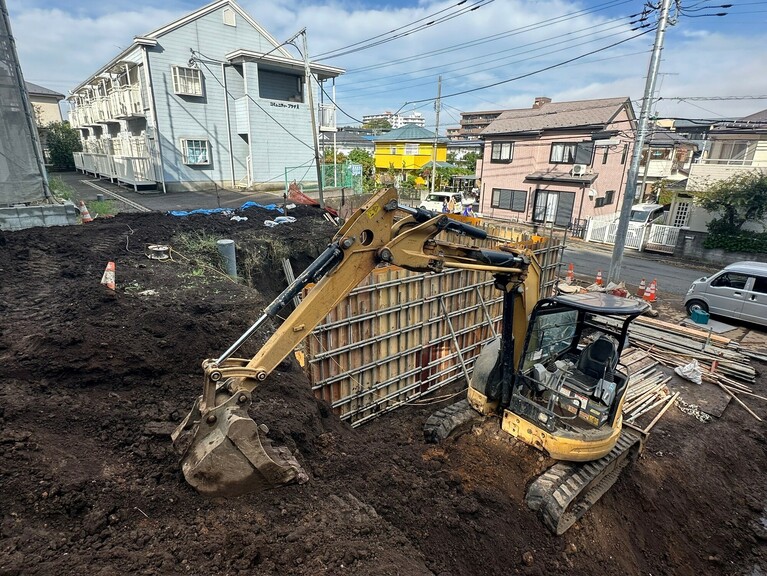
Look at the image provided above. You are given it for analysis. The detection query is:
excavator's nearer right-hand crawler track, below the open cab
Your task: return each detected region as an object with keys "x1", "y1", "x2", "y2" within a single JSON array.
[{"x1": 525, "y1": 428, "x2": 642, "y2": 536}]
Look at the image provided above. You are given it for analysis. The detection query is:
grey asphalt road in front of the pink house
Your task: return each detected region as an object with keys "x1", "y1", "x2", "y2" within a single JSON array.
[{"x1": 561, "y1": 242, "x2": 718, "y2": 296}]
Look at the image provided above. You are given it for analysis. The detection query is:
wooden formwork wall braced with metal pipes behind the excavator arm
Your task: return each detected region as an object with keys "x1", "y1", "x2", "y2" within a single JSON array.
[{"x1": 306, "y1": 230, "x2": 562, "y2": 426}]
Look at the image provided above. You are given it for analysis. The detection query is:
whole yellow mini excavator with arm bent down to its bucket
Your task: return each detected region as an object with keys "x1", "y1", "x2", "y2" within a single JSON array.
[{"x1": 172, "y1": 189, "x2": 646, "y2": 533}]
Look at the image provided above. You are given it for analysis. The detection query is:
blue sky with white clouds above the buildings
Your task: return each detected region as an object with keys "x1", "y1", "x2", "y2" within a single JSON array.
[{"x1": 6, "y1": 0, "x2": 767, "y2": 133}]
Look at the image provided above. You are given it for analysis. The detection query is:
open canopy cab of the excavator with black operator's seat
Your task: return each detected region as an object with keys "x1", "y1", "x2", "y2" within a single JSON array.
[{"x1": 503, "y1": 292, "x2": 647, "y2": 462}]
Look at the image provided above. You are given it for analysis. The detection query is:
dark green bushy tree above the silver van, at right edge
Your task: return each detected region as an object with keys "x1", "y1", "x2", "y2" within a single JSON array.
[{"x1": 695, "y1": 170, "x2": 767, "y2": 234}]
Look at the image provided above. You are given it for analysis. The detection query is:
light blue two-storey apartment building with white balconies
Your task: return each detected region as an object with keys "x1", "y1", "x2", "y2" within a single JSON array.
[{"x1": 68, "y1": 0, "x2": 343, "y2": 191}]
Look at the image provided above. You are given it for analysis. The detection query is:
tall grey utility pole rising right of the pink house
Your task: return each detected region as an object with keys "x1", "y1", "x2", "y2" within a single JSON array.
[{"x1": 607, "y1": 0, "x2": 671, "y2": 284}]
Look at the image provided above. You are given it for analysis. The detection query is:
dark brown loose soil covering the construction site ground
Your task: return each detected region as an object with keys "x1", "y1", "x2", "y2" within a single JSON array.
[{"x1": 0, "y1": 207, "x2": 767, "y2": 576}]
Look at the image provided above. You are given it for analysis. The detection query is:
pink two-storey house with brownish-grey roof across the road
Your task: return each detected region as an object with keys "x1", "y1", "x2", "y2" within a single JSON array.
[{"x1": 477, "y1": 97, "x2": 636, "y2": 227}]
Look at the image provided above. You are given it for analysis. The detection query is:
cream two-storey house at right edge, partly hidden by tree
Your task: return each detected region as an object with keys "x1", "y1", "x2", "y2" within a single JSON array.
[{"x1": 671, "y1": 110, "x2": 767, "y2": 232}]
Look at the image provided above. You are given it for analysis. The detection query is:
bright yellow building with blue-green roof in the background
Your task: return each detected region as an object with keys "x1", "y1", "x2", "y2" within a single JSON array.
[{"x1": 373, "y1": 124, "x2": 451, "y2": 176}]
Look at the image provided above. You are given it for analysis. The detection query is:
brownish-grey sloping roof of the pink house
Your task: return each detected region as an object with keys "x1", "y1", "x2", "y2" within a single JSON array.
[{"x1": 481, "y1": 97, "x2": 634, "y2": 136}]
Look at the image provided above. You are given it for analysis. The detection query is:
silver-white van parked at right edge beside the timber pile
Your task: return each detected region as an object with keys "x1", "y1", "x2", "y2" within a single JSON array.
[{"x1": 684, "y1": 262, "x2": 767, "y2": 326}]
